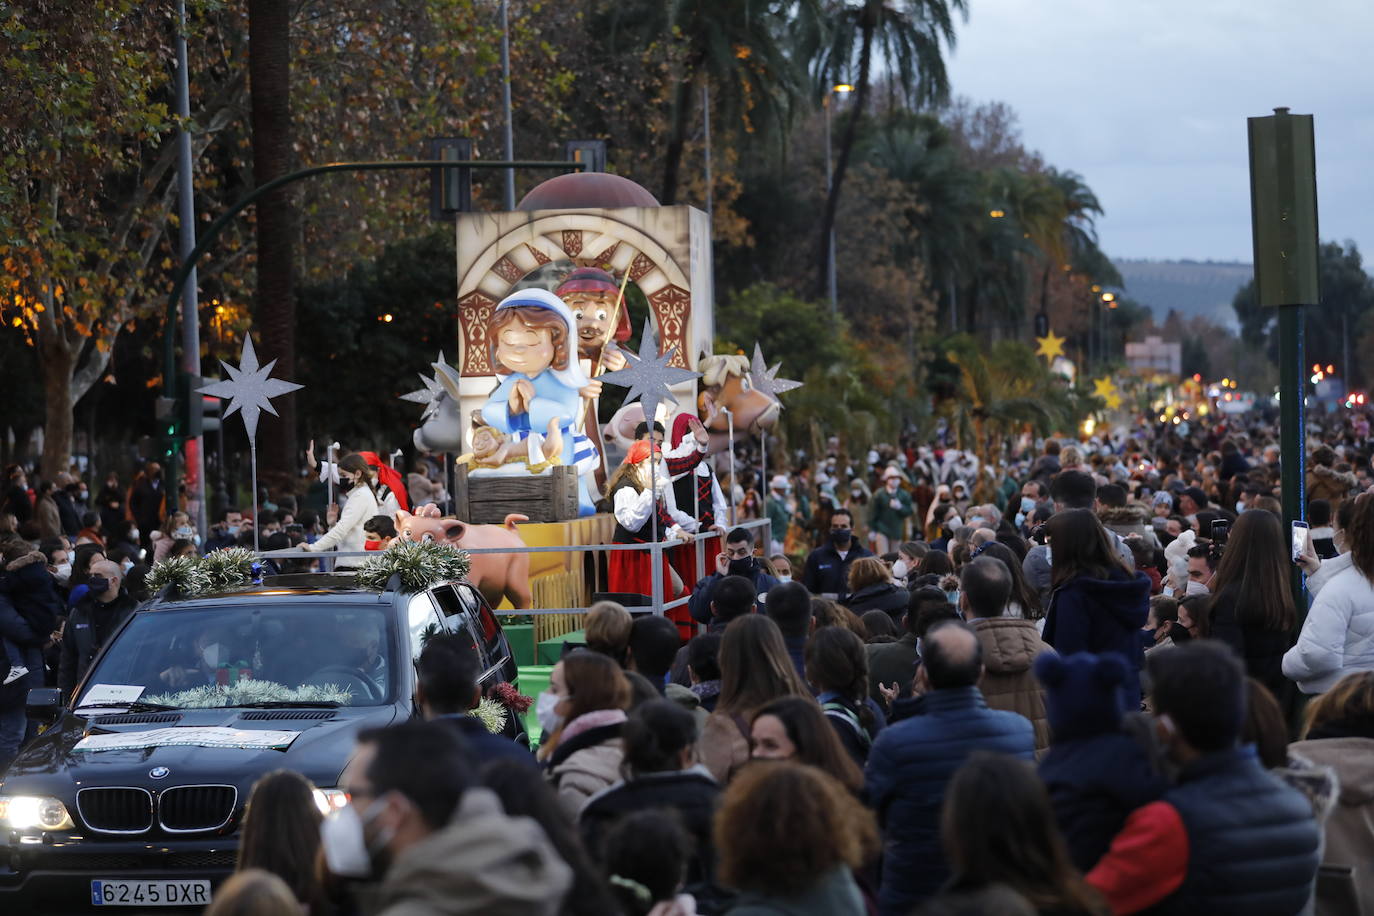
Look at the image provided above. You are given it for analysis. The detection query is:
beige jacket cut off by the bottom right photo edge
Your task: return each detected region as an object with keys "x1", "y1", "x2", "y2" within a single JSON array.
[{"x1": 1289, "y1": 737, "x2": 1374, "y2": 913}]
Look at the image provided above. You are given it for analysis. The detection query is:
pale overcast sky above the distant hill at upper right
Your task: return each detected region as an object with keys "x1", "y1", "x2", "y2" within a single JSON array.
[{"x1": 949, "y1": 0, "x2": 1374, "y2": 260}]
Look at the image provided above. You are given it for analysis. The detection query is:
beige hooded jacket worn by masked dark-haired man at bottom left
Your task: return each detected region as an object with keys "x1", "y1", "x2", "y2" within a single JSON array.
[{"x1": 375, "y1": 788, "x2": 573, "y2": 916}]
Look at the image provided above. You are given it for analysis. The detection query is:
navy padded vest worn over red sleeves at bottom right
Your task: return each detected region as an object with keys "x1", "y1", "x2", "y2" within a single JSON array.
[{"x1": 1157, "y1": 746, "x2": 1322, "y2": 916}]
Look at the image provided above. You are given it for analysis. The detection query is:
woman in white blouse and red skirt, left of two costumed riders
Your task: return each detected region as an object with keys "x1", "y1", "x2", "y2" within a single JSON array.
[{"x1": 606, "y1": 439, "x2": 697, "y2": 642}]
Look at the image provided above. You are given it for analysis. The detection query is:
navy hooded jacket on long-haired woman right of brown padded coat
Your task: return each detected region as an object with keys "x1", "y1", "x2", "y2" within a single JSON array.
[{"x1": 1043, "y1": 570, "x2": 1150, "y2": 710}]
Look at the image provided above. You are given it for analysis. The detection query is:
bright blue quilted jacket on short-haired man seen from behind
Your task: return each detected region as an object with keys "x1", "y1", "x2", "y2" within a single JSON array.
[{"x1": 864, "y1": 687, "x2": 1035, "y2": 916}]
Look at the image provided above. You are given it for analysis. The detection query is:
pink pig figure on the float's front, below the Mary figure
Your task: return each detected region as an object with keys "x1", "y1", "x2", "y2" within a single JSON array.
[{"x1": 396, "y1": 503, "x2": 533, "y2": 611}]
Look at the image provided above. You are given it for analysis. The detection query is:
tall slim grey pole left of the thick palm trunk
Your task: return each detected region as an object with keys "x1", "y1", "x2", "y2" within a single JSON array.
[{"x1": 168, "y1": 0, "x2": 206, "y2": 544}]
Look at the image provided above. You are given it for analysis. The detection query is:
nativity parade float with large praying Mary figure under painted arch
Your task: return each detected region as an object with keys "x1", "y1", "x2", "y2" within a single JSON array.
[{"x1": 407, "y1": 172, "x2": 786, "y2": 656}]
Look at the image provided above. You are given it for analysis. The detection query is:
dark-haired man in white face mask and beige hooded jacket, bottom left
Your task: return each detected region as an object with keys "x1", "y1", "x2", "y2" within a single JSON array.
[{"x1": 320, "y1": 722, "x2": 573, "y2": 916}]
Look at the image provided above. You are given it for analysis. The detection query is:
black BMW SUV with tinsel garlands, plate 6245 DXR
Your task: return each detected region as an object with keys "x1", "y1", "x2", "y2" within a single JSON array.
[{"x1": 0, "y1": 574, "x2": 525, "y2": 915}]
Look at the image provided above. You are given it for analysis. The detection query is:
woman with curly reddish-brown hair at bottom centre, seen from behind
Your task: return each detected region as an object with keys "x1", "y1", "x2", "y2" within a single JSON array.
[{"x1": 716, "y1": 762, "x2": 878, "y2": 916}]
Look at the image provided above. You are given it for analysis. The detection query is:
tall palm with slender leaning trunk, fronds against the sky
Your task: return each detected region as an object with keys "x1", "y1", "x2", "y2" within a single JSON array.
[{"x1": 794, "y1": 0, "x2": 969, "y2": 295}]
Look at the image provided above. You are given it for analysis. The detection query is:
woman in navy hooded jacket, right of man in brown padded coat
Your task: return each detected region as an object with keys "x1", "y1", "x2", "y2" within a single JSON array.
[{"x1": 1044, "y1": 509, "x2": 1150, "y2": 710}]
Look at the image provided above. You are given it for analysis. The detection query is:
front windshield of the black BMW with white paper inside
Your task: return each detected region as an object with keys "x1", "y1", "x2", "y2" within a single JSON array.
[{"x1": 76, "y1": 603, "x2": 400, "y2": 709}]
